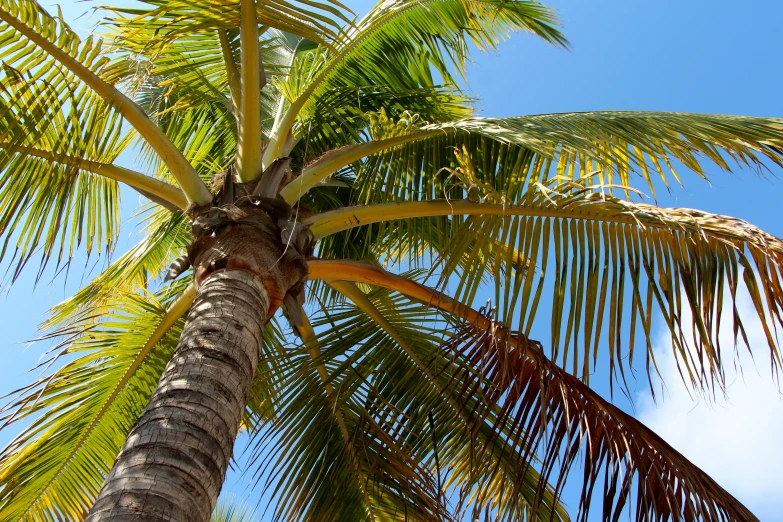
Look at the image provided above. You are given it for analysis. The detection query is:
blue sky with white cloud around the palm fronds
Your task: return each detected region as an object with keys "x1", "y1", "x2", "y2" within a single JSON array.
[{"x1": 0, "y1": 0, "x2": 783, "y2": 521}]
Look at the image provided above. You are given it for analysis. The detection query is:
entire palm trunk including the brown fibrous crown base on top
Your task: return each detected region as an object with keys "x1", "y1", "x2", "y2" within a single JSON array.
[{"x1": 86, "y1": 172, "x2": 313, "y2": 522}]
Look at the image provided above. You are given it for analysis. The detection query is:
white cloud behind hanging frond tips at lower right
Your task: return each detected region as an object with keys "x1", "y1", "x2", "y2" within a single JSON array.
[{"x1": 637, "y1": 290, "x2": 783, "y2": 521}]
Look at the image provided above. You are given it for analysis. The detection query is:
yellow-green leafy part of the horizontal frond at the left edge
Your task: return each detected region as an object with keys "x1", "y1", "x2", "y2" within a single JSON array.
[{"x1": 0, "y1": 71, "x2": 127, "y2": 279}]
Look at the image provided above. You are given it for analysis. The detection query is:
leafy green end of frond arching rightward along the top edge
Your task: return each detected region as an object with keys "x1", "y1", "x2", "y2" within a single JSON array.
[{"x1": 328, "y1": 0, "x2": 567, "y2": 90}]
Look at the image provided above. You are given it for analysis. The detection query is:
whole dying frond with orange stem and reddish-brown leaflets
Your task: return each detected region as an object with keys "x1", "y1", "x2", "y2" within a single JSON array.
[{"x1": 310, "y1": 261, "x2": 757, "y2": 521}]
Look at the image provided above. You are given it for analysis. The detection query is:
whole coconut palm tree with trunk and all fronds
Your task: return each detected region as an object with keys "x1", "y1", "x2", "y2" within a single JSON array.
[{"x1": 0, "y1": 0, "x2": 783, "y2": 522}]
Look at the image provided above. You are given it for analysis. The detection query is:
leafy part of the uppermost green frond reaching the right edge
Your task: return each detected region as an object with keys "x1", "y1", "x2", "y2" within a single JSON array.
[{"x1": 356, "y1": 112, "x2": 783, "y2": 204}]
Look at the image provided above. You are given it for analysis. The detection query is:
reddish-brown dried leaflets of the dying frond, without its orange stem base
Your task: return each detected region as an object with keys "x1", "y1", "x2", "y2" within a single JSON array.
[{"x1": 446, "y1": 324, "x2": 758, "y2": 521}]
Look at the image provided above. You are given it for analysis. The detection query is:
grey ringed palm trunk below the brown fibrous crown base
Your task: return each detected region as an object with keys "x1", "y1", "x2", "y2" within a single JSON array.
[{"x1": 86, "y1": 269, "x2": 270, "y2": 522}]
